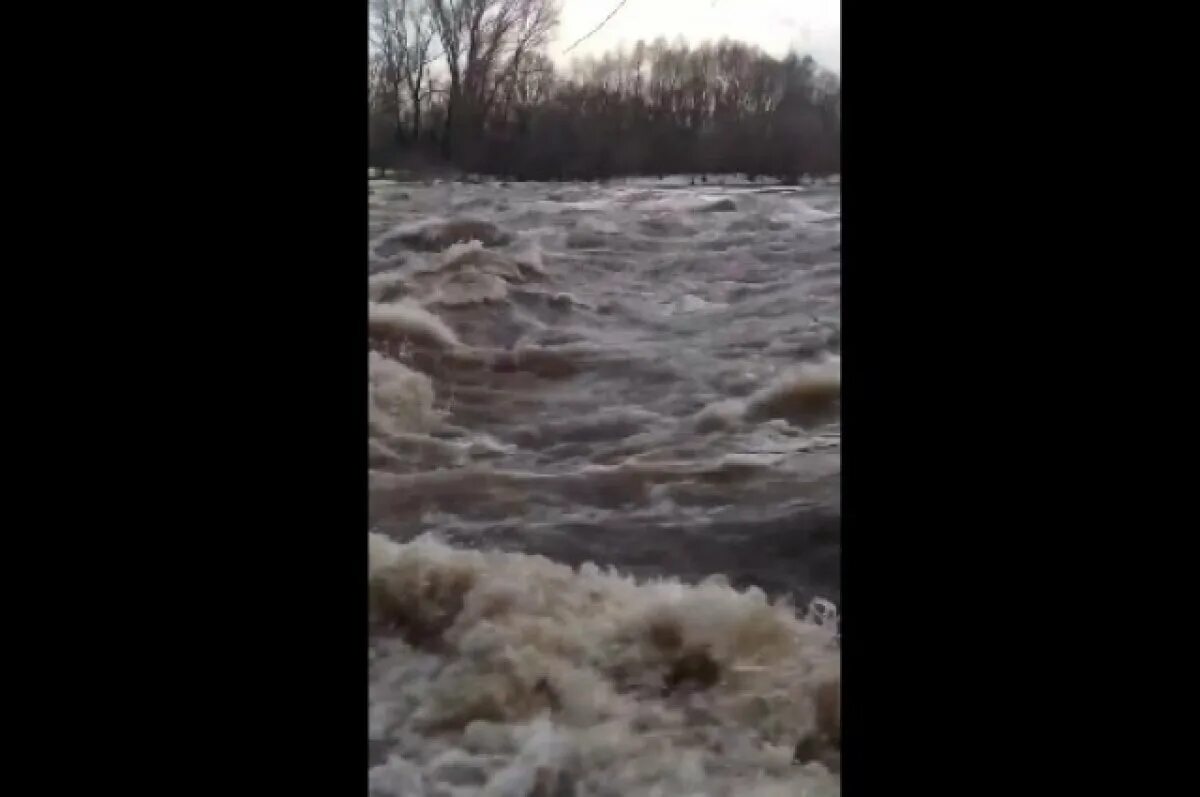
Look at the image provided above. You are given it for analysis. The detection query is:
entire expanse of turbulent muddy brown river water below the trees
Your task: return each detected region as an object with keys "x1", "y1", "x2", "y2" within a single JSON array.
[{"x1": 367, "y1": 179, "x2": 841, "y2": 797}]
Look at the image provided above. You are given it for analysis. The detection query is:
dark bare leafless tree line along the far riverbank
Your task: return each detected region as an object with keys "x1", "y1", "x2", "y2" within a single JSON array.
[{"x1": 367, "y1": 0, "x2": 841, "y2": 180}]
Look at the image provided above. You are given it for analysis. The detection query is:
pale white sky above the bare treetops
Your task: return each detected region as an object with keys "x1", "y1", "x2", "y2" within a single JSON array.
[{"x1": 550, "y1": 0, "x2": 841, "y2": 72}]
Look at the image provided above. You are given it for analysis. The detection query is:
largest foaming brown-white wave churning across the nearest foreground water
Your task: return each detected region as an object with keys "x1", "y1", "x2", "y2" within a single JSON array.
[{"x1": 368, "y1": 534, "x2": 840, "y2": 797}]
